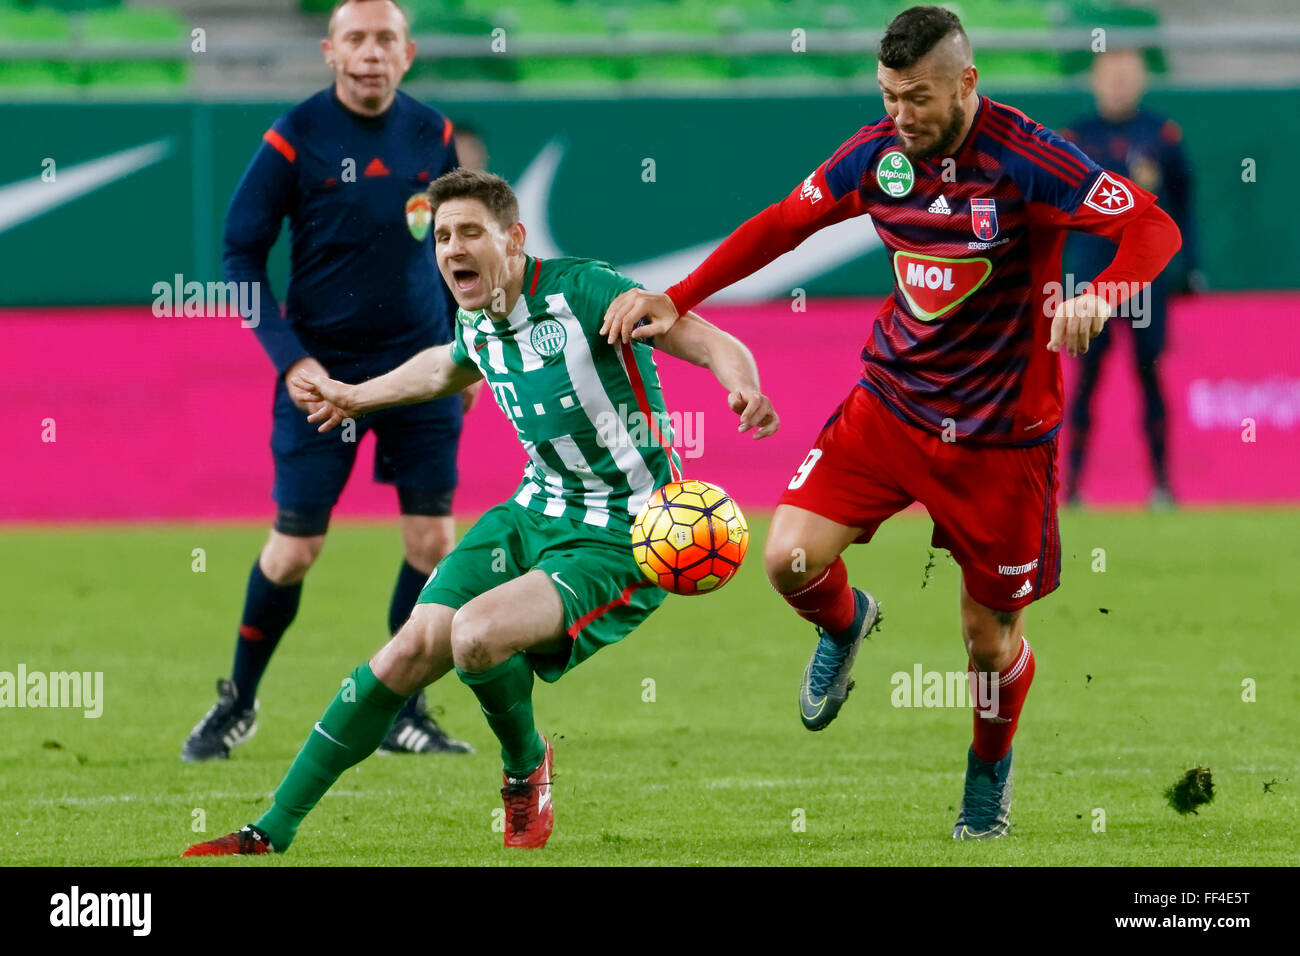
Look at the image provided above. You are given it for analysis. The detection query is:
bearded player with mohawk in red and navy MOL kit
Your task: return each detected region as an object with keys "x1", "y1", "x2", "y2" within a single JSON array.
[{"x1": 603, "y1": 7, "x2": 1180, "y2": 839}]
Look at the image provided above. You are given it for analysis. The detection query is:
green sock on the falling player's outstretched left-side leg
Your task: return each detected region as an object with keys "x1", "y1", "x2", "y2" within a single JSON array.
[{"x1": 254, "y1": 663, "x2": 397, "y2": 852}]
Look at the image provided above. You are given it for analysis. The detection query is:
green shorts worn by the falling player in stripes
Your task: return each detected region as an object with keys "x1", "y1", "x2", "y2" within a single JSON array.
[{"x1": 419, "y1": 501, "x2": 664, "y2": 682}]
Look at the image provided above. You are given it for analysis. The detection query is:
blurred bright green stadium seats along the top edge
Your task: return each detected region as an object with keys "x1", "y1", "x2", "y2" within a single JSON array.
[{"x1": 0, "y1": 0, "x2": 1165, "y2": 94}]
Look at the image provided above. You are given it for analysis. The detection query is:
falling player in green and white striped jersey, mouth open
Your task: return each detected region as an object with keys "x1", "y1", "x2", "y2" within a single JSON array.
[{"x1": 185, "y1": 169, "x2": 780, "y2": 856}]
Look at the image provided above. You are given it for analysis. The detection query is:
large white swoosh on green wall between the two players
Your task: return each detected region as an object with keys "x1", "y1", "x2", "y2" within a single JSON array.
[{"x1": 515, "y1": 139, "x2": 881, "y2": 302}]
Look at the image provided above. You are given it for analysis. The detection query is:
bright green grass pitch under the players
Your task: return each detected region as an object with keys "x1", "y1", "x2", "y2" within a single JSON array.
[{"x1": 0, "y1": 510, "x2": 1300, "y2": 866}]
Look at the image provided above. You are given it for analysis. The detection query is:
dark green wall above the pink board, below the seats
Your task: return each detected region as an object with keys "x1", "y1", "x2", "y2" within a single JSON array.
[{"x1": 0, "y1": 90, "x2": 1300, "y2": 306}]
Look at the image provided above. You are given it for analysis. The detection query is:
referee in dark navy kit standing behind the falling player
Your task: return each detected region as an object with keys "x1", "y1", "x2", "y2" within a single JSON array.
[{"x1": 181, "y1": 0, "x2": 472, "y2": 761}]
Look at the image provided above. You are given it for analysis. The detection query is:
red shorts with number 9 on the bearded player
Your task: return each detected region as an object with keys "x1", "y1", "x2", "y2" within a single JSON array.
[{"x1": 780, "y1": 385, "x2": 1061, "y2": 611}]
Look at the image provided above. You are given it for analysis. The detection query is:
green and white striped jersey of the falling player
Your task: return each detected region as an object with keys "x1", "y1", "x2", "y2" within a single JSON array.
[{"x1": 451, "y1": 256, "x2": 681, "y2": 531}]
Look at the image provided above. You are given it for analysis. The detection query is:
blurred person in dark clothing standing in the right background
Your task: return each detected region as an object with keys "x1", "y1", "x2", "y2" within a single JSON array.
[{"x1": 1061, "y1": 49, "x2": 1205, "y2": 507}]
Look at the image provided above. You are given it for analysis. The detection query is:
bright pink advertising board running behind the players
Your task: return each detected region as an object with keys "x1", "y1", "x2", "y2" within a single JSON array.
[{"x1": 0, "y1": 293, "x2": 1300, "y2": 523}]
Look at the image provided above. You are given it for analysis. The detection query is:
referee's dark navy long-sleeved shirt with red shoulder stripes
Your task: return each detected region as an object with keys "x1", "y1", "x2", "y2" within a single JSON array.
[{"x1": 224, "y1": 87, "x2": 459, "y2": 381}]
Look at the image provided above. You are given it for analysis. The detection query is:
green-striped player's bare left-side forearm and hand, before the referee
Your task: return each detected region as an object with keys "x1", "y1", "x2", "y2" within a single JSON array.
[{"x1": 293, "y1": 345, "x2": 480, "y2": 432}]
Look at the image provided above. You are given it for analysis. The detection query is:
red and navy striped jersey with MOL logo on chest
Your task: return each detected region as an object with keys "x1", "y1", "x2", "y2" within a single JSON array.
[{"x1": 780, "y1": 98, "x2": 1154, "y2": 445}]
